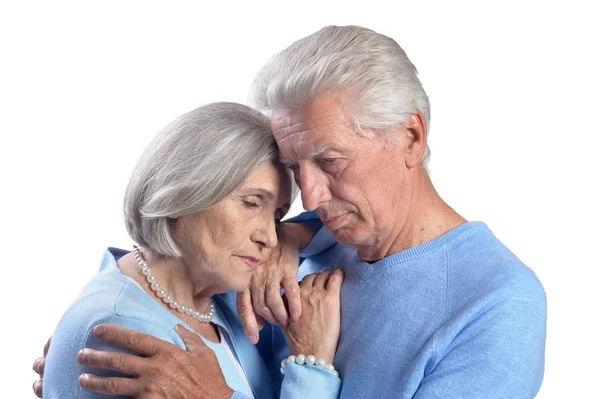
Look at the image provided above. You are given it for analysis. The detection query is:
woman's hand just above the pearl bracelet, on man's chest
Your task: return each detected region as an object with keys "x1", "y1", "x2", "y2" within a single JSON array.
[{"x1": 283, "y1": 269, "x2": 344, "y2": 364}]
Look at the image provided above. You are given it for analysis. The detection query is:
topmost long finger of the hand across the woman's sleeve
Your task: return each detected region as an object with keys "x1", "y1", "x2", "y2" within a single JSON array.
[{"x1": 94, "y1": 324, "x2": 166, "y2": 356}]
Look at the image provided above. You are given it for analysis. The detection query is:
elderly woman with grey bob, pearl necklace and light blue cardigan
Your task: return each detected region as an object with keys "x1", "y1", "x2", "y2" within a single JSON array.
[{"x1": 43, "y1": 103, "x2": 342, "y2": 398}]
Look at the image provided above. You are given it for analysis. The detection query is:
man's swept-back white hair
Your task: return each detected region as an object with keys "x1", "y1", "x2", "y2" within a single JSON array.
[{"x1": 249, "y1": 26, "x2": 430, "y2": 167}]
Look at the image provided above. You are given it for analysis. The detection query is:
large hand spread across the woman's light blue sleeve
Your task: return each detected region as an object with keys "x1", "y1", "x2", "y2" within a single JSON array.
[{"x1": 77, "y1": 324, "x2": 233, "y2": 399}]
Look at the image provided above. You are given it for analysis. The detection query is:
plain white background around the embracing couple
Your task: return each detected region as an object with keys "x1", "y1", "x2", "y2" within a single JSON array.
[{"x1": 0, "y1": 0, "x2": 600, "y2": 398}]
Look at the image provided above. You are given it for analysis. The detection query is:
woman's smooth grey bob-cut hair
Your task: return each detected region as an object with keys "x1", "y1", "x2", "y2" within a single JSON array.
[{"x1": 124, "y1": 103, "x2": 278, "y2": 256}]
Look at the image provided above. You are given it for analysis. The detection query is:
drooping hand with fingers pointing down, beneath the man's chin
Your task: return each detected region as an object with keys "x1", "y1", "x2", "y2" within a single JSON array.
[{"x1": 237, "y1": 223, "x2": 315, "y2": 343}]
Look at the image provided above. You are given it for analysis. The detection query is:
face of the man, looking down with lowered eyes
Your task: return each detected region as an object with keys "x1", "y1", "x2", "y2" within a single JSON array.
[{"x1": 272, "y1": 94, "x2": 408, "y2": 252}]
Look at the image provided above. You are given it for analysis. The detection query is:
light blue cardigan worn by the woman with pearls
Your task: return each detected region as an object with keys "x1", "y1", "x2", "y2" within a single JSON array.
[{"x1": 43, "y1": 248, "x2": 341, "y2": 399}]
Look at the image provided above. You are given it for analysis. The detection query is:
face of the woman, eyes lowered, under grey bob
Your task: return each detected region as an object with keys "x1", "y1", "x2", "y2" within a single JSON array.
[{"x1": 175, "y1": 163, "x2": 291, "y2": 292}]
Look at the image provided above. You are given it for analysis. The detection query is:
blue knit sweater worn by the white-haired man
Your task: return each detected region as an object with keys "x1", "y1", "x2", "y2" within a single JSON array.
[{"x1": 273, "y1": 222, "x2": 546, "y2": 399}]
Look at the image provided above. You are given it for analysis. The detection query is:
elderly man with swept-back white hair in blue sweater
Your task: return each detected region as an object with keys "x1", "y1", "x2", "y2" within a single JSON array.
[{"x1": 35, "y1": 26, "x2": 546, "y2": 398}]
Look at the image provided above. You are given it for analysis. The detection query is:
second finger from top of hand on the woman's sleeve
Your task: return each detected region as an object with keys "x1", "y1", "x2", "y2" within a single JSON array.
[{"x1": 77, "y1": 348, "x2": 146, "y2": 375}]
